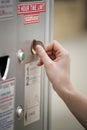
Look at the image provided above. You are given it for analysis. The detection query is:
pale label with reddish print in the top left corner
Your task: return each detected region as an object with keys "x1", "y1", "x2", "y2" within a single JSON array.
[{"x1": 0, "y1": 0, "x2": 13, "y2": 18}]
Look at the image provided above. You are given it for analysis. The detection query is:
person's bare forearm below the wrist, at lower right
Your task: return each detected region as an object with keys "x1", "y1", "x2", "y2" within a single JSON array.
[{"x1": 57, "y1": 83, "x2": 87, "y2": 129}]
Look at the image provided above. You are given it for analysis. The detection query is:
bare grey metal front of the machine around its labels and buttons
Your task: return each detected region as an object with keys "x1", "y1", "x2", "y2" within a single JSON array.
[{"x1": 0, "y1": 0, "x2": 52, "y2": 130}]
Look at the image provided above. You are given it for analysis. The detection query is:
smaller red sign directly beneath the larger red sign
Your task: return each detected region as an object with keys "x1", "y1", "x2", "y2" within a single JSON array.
[{"x1": 24, "y1": 13, "x2": 40, "y2": 24}]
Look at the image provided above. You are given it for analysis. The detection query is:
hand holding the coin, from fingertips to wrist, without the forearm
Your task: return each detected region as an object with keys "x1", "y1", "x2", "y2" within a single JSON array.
[{"x1": 36, "y1": 41, "x2": 71, "y2": 95}]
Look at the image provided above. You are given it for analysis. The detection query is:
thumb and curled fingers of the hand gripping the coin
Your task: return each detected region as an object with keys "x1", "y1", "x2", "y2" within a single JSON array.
[{"x1": 36, "y1": 41, "x2": 66, "y2": 67}]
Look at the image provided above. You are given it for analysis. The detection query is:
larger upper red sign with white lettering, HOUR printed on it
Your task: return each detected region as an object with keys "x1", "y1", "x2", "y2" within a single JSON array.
[{"x1": 18, "y1": 2, "x2": 46, "y2": 14}]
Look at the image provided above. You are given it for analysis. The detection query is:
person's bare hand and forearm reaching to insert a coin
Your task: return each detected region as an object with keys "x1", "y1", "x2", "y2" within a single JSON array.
[{"x1": 36, "y1": 41, "x2": 87, "y2": 129}]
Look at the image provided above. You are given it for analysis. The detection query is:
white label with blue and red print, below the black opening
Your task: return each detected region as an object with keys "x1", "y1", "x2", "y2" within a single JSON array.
[{"x1": 0, "y1": 79, "x2": 15, "y2": 130}]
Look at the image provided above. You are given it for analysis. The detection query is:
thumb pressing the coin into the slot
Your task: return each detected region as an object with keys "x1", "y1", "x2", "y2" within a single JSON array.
[{"x1": 36, "y1": 45, "x2": 52, "y2": 67}]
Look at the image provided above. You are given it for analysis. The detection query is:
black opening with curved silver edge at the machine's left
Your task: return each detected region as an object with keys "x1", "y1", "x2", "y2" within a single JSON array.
[{"x1": 0, "y1": 56, "x2": 10, "y2": 80}]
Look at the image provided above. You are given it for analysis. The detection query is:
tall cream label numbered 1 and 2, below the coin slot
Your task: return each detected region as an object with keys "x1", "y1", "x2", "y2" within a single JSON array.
[{"x1": 24, "y1": 62, "x2": 41, "y2": 125}]
